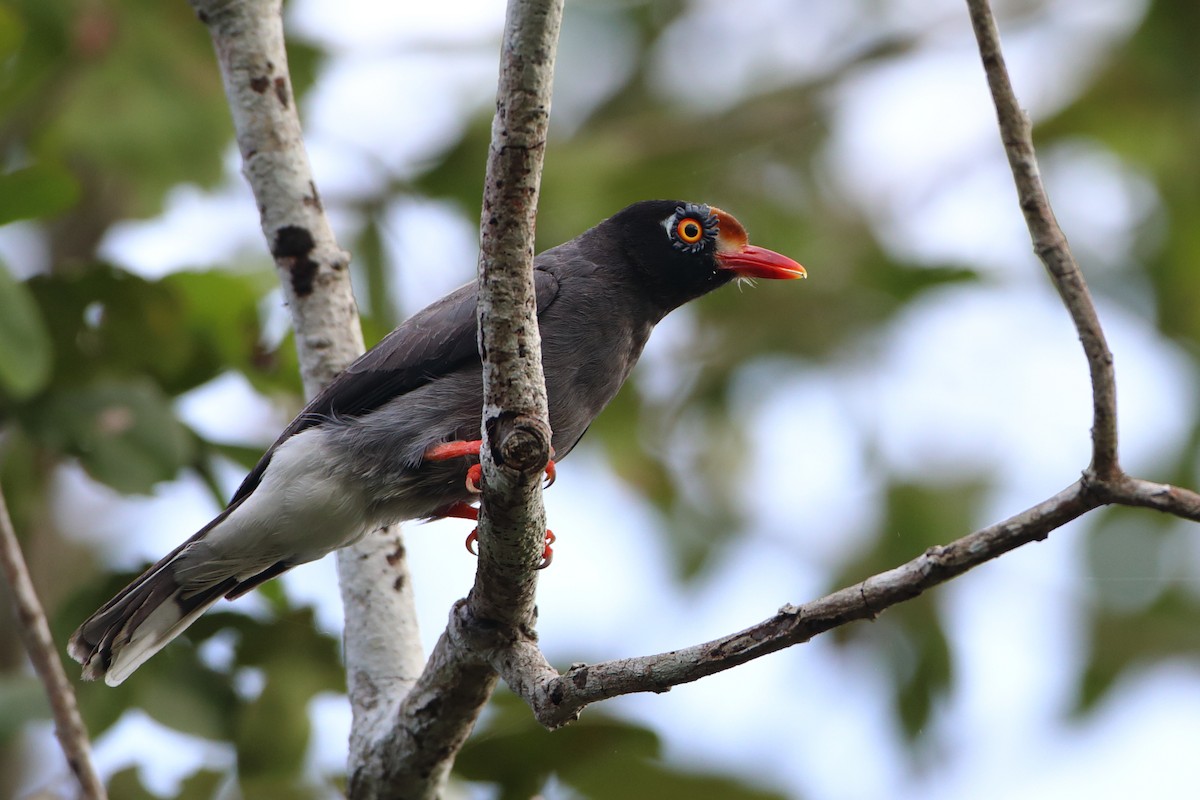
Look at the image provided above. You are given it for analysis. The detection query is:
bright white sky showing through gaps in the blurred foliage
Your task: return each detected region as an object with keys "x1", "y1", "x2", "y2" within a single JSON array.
[{"x1": 18, "y1": 0, "x2": 1200, "y2": 800}]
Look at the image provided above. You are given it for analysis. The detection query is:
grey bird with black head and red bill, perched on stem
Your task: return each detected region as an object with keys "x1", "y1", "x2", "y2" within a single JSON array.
[{"x1": 68, "y1": 200, "x2": 808, "y2": 686}]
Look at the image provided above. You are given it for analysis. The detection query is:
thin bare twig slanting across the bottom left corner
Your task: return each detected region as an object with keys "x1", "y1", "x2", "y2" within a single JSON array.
[{"x1": 0, "y1": 482, "x2": 108, "y2": 800}]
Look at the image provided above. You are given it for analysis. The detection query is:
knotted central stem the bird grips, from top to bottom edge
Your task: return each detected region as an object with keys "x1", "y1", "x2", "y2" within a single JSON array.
[{"x1": 349, "y1": 0, "x2": 563, "y2": 800}]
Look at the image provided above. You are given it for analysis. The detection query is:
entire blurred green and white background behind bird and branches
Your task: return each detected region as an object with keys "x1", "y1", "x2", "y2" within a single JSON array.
[{"x1": 0, "y1": 0, "x2": 1200, "y2": 800}]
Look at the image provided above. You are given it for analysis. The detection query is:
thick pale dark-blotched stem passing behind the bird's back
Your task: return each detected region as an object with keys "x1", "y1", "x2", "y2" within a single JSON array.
[{"x1": 192, "y1": 0, "x2": 424, "y2": 786}]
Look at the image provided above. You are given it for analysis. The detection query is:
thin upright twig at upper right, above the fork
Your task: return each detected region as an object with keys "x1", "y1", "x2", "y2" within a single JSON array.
[{"x1": 967, "y1": 0, "x2": 1121, "y2": 480}]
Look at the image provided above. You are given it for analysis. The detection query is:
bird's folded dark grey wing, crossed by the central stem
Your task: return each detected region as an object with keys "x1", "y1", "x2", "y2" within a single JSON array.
[{"x1": 230, "y1": 269, "x2": 558, "y2": 504}]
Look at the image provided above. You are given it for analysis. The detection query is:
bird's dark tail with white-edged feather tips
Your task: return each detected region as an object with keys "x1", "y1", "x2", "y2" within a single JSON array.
[{"x1": 67, "y1": 547, "x2": 236, "y2": 686}]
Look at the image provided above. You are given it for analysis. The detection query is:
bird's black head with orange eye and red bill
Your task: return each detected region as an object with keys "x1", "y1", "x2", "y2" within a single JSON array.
[{"x1": 604, "y1": 200, "x2": 808, "y2": 313}]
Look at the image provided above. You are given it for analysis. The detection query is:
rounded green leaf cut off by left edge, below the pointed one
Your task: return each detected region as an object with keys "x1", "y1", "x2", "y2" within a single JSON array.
[{"x1": 0, "y1": 263, "x2": 52, "y2": 399}]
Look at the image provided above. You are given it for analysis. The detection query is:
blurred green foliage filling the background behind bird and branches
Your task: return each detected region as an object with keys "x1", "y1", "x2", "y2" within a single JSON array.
[{"x1": 0, "y1": 0, "x2": 1200, "y2": 800}]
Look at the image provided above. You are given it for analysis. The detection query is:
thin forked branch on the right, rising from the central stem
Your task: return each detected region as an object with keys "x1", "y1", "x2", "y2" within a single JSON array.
[{"x1": 492, "y1": 0, "x2": 1200, "y2": 728}]
